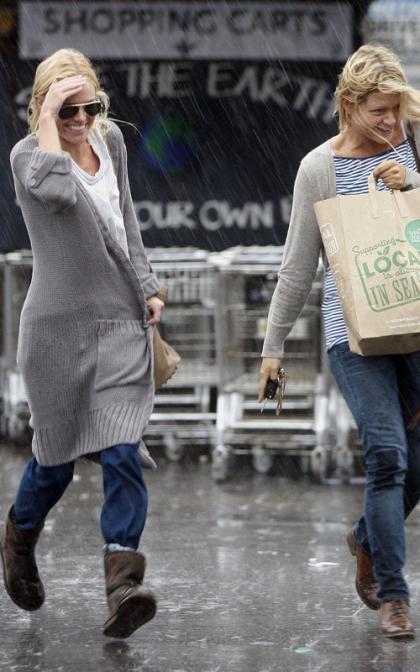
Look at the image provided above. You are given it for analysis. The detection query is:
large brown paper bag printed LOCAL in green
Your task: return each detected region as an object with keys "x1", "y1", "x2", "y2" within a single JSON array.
[{"x1": 315, "y1": 174, "x2": 420, "y2": 355}]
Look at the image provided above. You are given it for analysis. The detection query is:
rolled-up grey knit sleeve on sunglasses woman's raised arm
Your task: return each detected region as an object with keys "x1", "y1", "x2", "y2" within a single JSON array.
[{"x1": 10, "y1": 143, "x2": 76, "y2": 214}]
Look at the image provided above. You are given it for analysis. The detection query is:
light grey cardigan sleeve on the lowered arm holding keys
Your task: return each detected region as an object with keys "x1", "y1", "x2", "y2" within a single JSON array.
[{"x1": 262, "y1": 165, "x2": 322, "y2": 359}]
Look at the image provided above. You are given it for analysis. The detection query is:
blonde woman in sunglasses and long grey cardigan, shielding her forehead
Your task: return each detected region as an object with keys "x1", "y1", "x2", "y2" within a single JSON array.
[{"x1": 0, "y1": 49, "x2": 163, "y2": 637}]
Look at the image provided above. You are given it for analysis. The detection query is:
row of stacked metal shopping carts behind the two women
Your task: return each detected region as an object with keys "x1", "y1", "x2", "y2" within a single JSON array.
[{"x1": 0, "y1": 247, "x2": 360, "y2": 481}]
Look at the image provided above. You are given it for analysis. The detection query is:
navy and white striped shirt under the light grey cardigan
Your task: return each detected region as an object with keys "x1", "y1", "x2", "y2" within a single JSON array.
[{"x1": 321, "y1": 139, "x2": 417, "y2": 350}]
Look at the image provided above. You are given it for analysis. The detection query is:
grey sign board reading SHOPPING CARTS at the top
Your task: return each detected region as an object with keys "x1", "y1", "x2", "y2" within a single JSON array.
[{"x1": 19, "y1": 1, "x2": 353, "y2": 62}]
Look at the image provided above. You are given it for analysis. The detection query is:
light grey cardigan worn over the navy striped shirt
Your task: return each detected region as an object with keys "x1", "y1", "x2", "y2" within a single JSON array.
[{"x1": 262, "y1": 124, "x2": 420, "y2": 359}]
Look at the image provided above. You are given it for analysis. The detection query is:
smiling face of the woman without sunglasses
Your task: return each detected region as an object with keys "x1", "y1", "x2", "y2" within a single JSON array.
[{"x1": 349, "y1": 91, "x2": 401, "y2": 146}]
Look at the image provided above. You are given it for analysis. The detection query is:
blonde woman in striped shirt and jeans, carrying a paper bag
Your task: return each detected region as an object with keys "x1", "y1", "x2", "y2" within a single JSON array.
[{"x1": 259, "y1": 45, "x2": 420, "y2": 638}]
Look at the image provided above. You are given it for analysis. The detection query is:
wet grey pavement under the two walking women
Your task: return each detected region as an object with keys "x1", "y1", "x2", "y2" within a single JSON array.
[{"x1": 0, "y1": 445, "x2": 420, "y2": 672}]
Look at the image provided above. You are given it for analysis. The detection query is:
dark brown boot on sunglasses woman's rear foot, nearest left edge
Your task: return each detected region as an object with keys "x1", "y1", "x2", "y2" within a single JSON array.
[{"x1": 0, "y1": 507, "x2": 45, "y2": 611}]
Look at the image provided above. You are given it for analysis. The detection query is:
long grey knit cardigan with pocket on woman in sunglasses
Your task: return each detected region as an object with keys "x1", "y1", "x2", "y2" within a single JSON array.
[{"x1": 11, "y1": 122, "x2": 159, "y2": 466}]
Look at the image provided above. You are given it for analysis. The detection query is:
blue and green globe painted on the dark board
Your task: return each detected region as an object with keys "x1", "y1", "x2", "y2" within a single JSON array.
[{"x1": 140, "y1": 114, "x2": 197, "y2": 173}]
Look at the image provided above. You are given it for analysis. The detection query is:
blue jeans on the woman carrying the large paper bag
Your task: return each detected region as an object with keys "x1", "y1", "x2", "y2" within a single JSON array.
[{"x1": 328, "y1": 343, "x2": 420, "y2": 602}]
